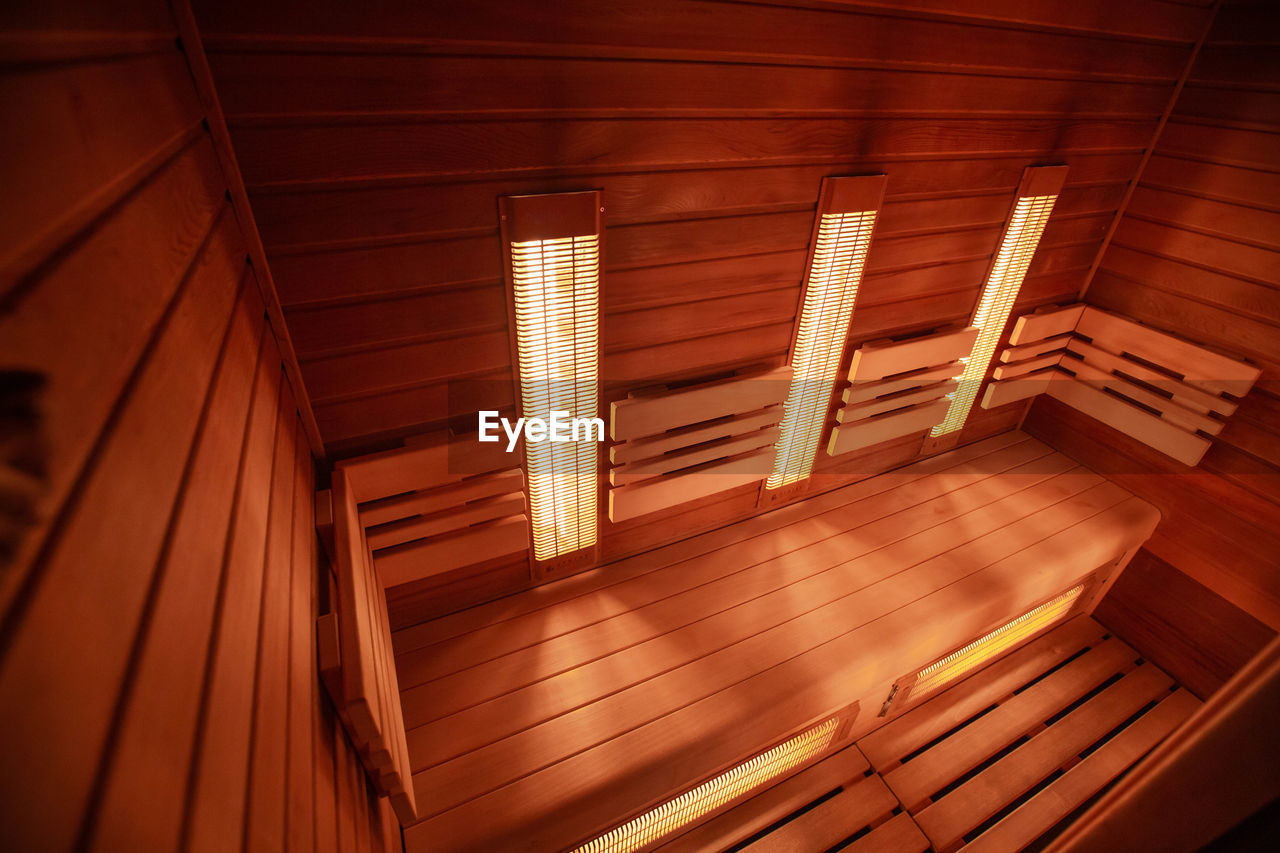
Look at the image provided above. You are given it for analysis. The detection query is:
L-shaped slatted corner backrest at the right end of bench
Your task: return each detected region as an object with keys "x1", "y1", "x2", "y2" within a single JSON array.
[{"x1": 982, "y1": 305, "x2": 1261, "y2": 465}]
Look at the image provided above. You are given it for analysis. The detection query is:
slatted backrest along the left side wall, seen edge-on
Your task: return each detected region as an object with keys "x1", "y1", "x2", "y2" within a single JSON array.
[{"x1": 317, "y1": 469, "x2": 417, "y2": 825}]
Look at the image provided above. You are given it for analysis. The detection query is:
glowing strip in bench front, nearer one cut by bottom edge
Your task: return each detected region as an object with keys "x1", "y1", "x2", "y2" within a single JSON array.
[{"x1": 575, "y1": 717, "x2": 840, "y2": 853}]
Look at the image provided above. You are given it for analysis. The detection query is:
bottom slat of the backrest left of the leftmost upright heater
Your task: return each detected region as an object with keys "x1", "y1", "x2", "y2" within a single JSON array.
[{"x1": 375, "y1": 514, "x2": 529, "y2": 588}]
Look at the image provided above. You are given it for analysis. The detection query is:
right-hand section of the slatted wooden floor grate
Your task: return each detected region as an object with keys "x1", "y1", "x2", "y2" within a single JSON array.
[{"x1": 858, "y1": 616, "x2": 1199, "y2": 853}]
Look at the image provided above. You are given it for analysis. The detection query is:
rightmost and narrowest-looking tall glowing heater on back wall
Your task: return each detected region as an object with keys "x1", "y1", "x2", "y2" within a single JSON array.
[{"x1": 929, "y1": 167, "x2": 1066, "y2": 435}]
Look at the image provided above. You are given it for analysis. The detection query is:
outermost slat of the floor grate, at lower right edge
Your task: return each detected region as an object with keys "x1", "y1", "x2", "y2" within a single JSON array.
[{"x1": 963, "y1": 689, "x2": 1201, "y2": 853}]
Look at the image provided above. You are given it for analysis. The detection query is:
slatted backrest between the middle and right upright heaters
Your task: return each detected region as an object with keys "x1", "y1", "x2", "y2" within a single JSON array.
[{"x1": 827, "y1": 327, "x2": 978, "y2": 456}]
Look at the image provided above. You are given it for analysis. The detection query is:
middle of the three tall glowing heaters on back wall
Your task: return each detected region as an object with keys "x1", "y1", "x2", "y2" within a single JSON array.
[{"x1": 764, "y1": 175, "x2": 884, "y2": 489}]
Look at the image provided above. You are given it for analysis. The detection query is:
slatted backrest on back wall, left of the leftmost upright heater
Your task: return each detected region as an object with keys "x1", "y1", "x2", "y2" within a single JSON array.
[{"x1": 338, "y1": 432, "x2": 529, "y2": 587}]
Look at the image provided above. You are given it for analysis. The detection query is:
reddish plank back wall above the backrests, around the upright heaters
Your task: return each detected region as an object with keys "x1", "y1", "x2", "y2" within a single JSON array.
[{"x1": 196, "y1": 0, "x2": 1211, "y2": 456}]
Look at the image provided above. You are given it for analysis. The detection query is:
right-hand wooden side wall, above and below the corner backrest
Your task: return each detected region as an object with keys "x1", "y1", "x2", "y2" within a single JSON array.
[{"x1": 1027, "y1": 0, "x2": 1280, "y2": 695}]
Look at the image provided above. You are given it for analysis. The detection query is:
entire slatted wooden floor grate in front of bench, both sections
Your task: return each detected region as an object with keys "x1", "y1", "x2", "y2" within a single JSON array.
[{"x1": 659, "y1": 616, "x2": 1199, "y2": 853}]
